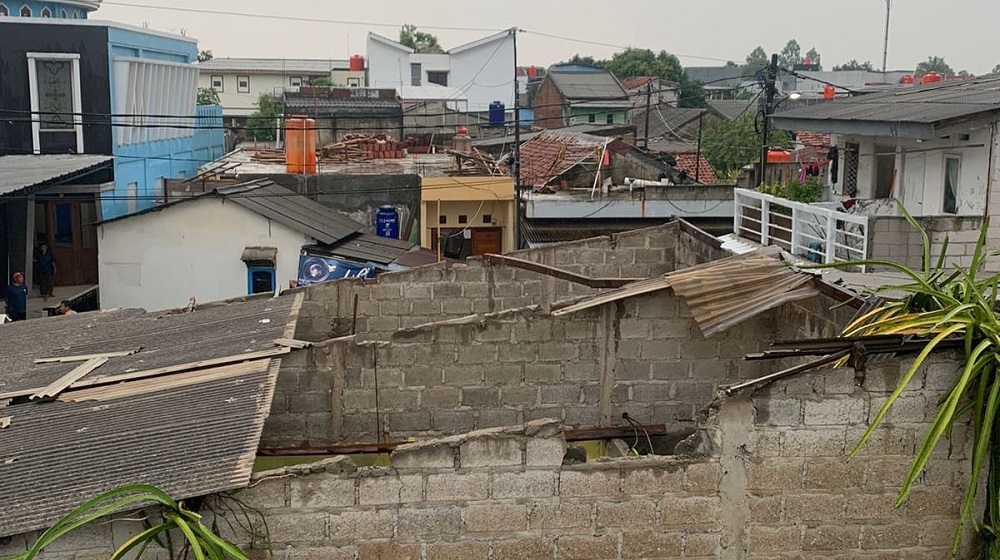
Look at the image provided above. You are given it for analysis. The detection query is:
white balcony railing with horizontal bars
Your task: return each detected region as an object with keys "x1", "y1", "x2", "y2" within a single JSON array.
[{"x1": 733, "y1": 189, "x2": 868, "y2": 270}]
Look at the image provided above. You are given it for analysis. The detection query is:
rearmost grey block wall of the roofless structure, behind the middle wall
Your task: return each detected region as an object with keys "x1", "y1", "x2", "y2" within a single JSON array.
[{"x1": 296, "y1": 222, "x2": 723, "y2": 341}]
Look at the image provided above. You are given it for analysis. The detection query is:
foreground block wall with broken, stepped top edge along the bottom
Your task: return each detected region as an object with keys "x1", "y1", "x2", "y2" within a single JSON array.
[{"x1": 13, "y1": 366, "x2": 976, "y2": 560}]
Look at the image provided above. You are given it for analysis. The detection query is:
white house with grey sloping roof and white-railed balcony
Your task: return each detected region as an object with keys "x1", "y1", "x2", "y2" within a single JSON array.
[{"x1": 734, "y1": 76, "x2": 1000, "y2": 269}]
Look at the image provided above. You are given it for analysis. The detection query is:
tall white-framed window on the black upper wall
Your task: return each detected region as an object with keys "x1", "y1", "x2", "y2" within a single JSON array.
[{"x1": 28, "y1": 53, "x2": 84, "y2": 154}]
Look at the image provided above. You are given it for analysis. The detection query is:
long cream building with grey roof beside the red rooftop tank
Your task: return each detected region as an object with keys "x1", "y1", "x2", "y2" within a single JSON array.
[{"x1": 198, "y1": 58, "x2": 365, "y2": 117}]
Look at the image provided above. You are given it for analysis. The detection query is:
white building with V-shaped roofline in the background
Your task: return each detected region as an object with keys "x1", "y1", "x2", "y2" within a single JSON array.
[{"x1": 368, "y1": 31, "x2": 514, "y2": 111}]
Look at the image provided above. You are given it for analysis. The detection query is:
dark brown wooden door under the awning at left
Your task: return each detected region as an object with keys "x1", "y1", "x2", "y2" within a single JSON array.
[{"x1": 45, "y1": 200, "x2": 97, "y2": 286}]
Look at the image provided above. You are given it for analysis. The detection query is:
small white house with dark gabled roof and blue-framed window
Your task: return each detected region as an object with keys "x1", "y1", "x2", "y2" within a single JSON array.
[{"x1": 97, "y1": 180, "x2": 412, "y2": 310}]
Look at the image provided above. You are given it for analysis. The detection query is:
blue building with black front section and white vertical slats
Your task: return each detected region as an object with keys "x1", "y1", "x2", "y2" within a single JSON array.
[{"x1": 0, "y1": 13, "x2": 225, "y2": 285}]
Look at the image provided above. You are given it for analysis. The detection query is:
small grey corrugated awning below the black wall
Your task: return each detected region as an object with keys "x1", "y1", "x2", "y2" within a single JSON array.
[{"x1": 0, "y1": 154, "x2": 112, "y2": 196}]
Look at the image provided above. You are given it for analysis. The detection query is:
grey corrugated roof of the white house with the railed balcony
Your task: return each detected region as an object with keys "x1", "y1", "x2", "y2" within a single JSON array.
[{"x1": 773, "y1": 76, "x2": 1000, "y2": 124}]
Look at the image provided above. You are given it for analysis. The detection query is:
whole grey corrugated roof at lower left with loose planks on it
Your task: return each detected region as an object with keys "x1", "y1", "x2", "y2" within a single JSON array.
[{"x1": 0, "y1": 296, "x2": 301, "y2": 537}]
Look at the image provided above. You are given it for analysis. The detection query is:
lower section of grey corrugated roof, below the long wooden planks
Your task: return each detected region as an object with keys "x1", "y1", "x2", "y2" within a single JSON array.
[{"x1": 0, "y1": 360, "x2": 278, "y2": 537}]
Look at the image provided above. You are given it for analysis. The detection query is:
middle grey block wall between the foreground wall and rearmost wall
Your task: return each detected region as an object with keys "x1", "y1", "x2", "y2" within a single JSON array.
[{"x1": 270, "y1": 291, "x2": 778, "y2": 448}]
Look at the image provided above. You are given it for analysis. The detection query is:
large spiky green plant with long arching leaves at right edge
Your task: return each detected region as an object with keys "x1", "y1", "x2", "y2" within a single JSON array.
[{"x1": 809, "y1": 208, "x2": 1000, "y2": 560}]
